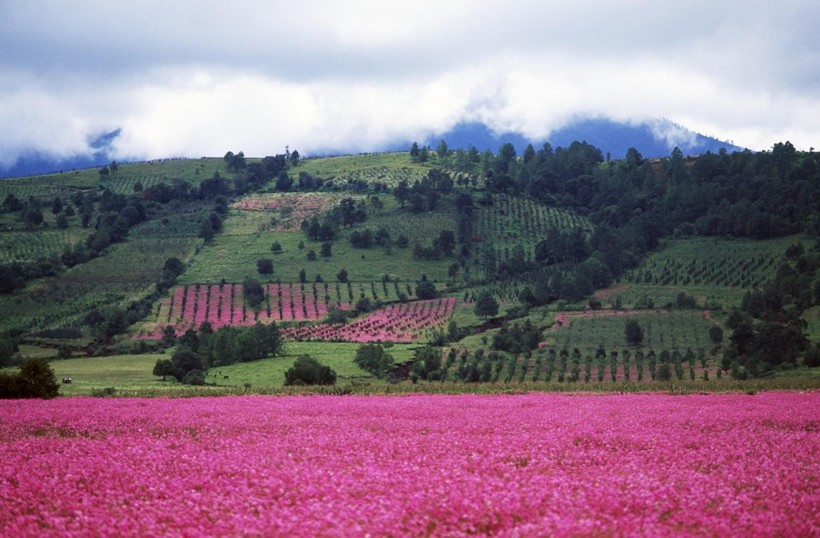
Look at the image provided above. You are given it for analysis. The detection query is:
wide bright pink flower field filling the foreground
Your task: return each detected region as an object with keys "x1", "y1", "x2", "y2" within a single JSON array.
[{"x1": 0, "y1": 392, "x2": 820, "y2": 536}]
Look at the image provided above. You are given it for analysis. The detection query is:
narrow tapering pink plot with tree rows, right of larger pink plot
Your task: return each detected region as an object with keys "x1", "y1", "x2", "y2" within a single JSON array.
[{"x1": 285, "y1": 297, "x2": 456, "y2": 343}]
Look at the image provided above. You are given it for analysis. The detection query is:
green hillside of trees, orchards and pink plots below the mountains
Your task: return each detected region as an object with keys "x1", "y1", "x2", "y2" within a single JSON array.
[{"x1": 0, "y1": 143, "x2": 820, "y2": 392}]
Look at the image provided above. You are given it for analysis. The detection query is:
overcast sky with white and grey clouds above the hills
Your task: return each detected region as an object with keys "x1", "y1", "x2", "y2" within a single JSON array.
[{"x1": 0, "y1": 0, "x2": 820, "y2": 166}]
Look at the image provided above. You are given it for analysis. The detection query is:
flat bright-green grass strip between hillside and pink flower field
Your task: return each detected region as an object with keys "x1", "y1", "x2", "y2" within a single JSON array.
[{"x1": 22, "y1": 343, "x2": 820, "y2": 396}]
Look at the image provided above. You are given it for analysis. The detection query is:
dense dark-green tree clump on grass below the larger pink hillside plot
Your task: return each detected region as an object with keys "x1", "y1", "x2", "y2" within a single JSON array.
[{"x1": 153, "y1": 321, "x2": 285, "y2": 384}]
